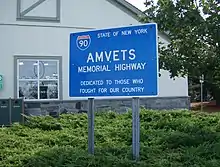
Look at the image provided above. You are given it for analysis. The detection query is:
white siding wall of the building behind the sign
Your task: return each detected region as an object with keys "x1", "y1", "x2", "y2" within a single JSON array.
[{"x1": 0, "y1": 0, "x2": 188, "y2": 100}]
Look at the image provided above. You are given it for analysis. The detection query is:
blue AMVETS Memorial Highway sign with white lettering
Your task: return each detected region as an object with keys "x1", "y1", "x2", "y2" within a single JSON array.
[{"x1": 69, "y1": 23, "x2": 158, "y2": 98}]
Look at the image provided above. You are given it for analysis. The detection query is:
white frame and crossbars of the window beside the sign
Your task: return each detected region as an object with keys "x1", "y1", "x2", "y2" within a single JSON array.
[{"x1": 15, "y1": 57, "x2": 62, "y2": 101}]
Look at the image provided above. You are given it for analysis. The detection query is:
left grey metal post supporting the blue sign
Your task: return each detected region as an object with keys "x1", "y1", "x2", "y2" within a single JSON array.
[{"x1": 88, "y1": 98, "x2": 95, "y2": 154}]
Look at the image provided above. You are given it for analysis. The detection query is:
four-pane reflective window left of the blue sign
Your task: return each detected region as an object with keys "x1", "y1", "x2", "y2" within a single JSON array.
[{"x1": 16, "y1": 59, "x2": 60, "y2": 100}]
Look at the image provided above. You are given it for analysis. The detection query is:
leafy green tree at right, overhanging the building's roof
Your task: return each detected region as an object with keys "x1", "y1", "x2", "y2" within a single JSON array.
[{"x1": 141, "y1": 0, "x2": 220, "y2": 103}]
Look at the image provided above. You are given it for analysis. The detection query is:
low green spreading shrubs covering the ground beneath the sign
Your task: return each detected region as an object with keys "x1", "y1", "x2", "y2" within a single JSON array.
[{"x1": 0, "y1": 109, "x2": 220, "y2": 167}]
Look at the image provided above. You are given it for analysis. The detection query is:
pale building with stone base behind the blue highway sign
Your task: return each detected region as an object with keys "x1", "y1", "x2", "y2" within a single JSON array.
[{"x1": 0, "y1": 0, "x2": 189, "y2": 113}]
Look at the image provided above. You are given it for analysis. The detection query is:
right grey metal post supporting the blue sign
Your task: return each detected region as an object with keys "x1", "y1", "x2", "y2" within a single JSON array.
[{"x1": 132, "y1": 97, "x2": 140, "y2": 160}]
